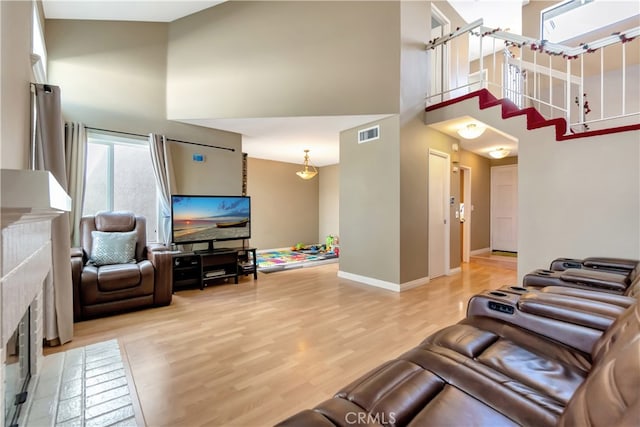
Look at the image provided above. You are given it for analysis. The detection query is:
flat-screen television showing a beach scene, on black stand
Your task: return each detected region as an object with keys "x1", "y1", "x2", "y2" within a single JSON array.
[{"x1": 171, "y1": 195, "x2": 251, "y2": 244}]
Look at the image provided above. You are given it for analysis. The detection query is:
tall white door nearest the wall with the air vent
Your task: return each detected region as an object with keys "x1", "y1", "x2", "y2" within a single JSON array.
[{"x1": 429, "y1": 151, "x2": 449, "y2": 279}]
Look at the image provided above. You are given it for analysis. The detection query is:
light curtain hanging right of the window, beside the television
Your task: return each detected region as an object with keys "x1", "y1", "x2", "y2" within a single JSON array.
[{"x1": 149, "y1": 133, "x2": 175, "y2": 246}]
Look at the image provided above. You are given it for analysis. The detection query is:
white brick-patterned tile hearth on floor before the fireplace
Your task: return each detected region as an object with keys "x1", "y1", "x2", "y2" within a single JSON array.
[{"x1": 25, "y1": 340, "x2": 143, "y2": 427}]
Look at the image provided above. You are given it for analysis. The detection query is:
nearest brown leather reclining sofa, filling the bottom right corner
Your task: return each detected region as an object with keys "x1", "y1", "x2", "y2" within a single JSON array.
[{"x1": 278, "y1": 262, "x2": 640, "y2": 427}]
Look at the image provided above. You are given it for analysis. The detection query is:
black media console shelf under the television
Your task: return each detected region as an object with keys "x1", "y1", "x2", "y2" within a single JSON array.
[{"x1": 173, "y1": 248, "x2": 258, "y2": 291}]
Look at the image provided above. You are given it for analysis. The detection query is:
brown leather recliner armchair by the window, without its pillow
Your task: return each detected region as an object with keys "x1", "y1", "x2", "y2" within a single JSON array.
[{"x1": 71, "y1": 212, "x2": 172, "y2": 321}]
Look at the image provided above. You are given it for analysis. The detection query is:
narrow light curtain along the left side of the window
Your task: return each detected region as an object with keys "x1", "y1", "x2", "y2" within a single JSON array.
[{"x1": 64, "y1": 122, "x2": 87, "y2": 247}]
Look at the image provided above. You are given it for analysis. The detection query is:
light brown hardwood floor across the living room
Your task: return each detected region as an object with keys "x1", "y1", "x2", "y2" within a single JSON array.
[{"x1": 45, "y1": 264, "x2": 516, "y2": 427}]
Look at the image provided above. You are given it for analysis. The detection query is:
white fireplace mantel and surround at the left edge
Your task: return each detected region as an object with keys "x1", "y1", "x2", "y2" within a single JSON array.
[{"x1": 0, "y1": 169, "x2": 71, "y2": 427}]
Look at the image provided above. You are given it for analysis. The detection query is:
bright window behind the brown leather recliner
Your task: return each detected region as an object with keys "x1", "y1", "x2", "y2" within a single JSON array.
[{"x1": 82, "y1": 132, "x2": 158, "y2": 242}]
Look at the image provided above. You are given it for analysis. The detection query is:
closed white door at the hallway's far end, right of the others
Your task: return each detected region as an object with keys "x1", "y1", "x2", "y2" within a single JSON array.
[{"x1": 491, "y1": 165, "x2": 518, "y2": 252}]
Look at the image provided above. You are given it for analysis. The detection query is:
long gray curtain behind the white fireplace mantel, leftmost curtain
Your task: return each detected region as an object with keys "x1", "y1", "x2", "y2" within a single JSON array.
[{"x1": 33, "y1": 84, "x2": 73, "y2": 344}]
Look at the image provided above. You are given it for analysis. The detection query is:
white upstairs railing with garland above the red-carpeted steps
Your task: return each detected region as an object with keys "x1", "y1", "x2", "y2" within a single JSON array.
[{"x1": 426, "y1": 19, "x2": 640, "y2": 133}]
